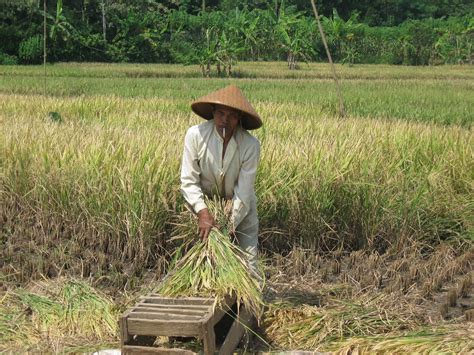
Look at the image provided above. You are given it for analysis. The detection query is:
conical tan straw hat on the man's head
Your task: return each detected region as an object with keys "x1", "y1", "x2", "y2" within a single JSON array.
[{"x1": 191, "y1": 85, "x2": 263, "y2": 130}]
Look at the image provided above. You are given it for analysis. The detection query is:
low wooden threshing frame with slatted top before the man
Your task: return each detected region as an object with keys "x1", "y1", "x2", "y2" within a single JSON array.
[{"x1": 119, "y1": 293, "x2": 252, "y2": 355}]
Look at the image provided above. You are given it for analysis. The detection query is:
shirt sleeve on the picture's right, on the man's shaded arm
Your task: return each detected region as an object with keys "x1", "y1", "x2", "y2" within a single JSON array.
[{"x1": 232, "y1": 139, "x2": 260, "y2": 228}]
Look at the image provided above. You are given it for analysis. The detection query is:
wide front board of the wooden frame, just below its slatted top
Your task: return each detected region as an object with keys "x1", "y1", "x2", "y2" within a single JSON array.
[{"x1": 127, "y1": 317, "x2": 202, "y2": 337}]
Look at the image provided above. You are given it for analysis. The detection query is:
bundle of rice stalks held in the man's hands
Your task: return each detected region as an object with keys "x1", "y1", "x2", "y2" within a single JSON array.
[{"x1": 156, "y1": 200, "x2": 263, "y2": 318}]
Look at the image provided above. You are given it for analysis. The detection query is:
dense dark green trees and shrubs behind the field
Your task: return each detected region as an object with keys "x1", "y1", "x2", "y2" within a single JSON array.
[{"x1": 0, "y1": 0, "x2": 474, "y2": 69}]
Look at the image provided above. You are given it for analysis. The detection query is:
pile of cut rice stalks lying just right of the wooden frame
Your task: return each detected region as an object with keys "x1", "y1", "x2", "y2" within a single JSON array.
[{"x1": 264, "y1": 299, "x2": 416, "y2": 350}]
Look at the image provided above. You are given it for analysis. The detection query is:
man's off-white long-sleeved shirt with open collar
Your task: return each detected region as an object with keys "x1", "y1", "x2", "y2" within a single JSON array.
[{"x1": 181, "y1": 120, "x2": 260, "y2": 228}]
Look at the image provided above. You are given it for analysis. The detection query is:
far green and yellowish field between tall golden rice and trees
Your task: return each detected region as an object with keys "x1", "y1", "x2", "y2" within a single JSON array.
[{"x1": 0, "y1": 63, "x2": 474, "y2": 126}]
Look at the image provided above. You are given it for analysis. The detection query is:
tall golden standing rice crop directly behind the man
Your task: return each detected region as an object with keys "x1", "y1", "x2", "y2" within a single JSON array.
[{"x1": 0, "y1": 89, "x2": 474, "y2": 284}]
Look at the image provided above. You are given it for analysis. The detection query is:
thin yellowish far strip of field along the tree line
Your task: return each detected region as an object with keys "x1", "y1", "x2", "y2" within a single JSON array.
[{"x1": 0, "y1": 62, "x2": 474, "y2": 80}]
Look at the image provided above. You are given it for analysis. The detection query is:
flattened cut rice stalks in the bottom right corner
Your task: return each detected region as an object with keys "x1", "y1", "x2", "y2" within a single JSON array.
[{"x1": 333, "y1": 325, "x2": 474, "y2": 355}]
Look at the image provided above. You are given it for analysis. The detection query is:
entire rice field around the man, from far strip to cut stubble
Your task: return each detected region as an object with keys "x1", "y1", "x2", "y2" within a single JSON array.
[{"x1": 0, "y1": 63, "x2": 474, "y2": 352}]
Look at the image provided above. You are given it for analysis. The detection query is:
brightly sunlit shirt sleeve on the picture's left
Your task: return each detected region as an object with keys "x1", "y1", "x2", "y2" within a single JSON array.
[{"x1": 181, "y1": 127, "x2": 207, "y2": 213}]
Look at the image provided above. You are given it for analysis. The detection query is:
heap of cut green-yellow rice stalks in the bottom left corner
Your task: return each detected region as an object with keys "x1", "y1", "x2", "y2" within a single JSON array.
[{"x1": 0, "y1": 279, "x2": 118, "y2": 352}]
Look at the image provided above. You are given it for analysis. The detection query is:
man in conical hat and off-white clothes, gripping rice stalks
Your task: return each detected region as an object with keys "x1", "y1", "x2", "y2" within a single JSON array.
[{"x1": 181, "y1": 85, "x2": 262, "y2": 271}]
